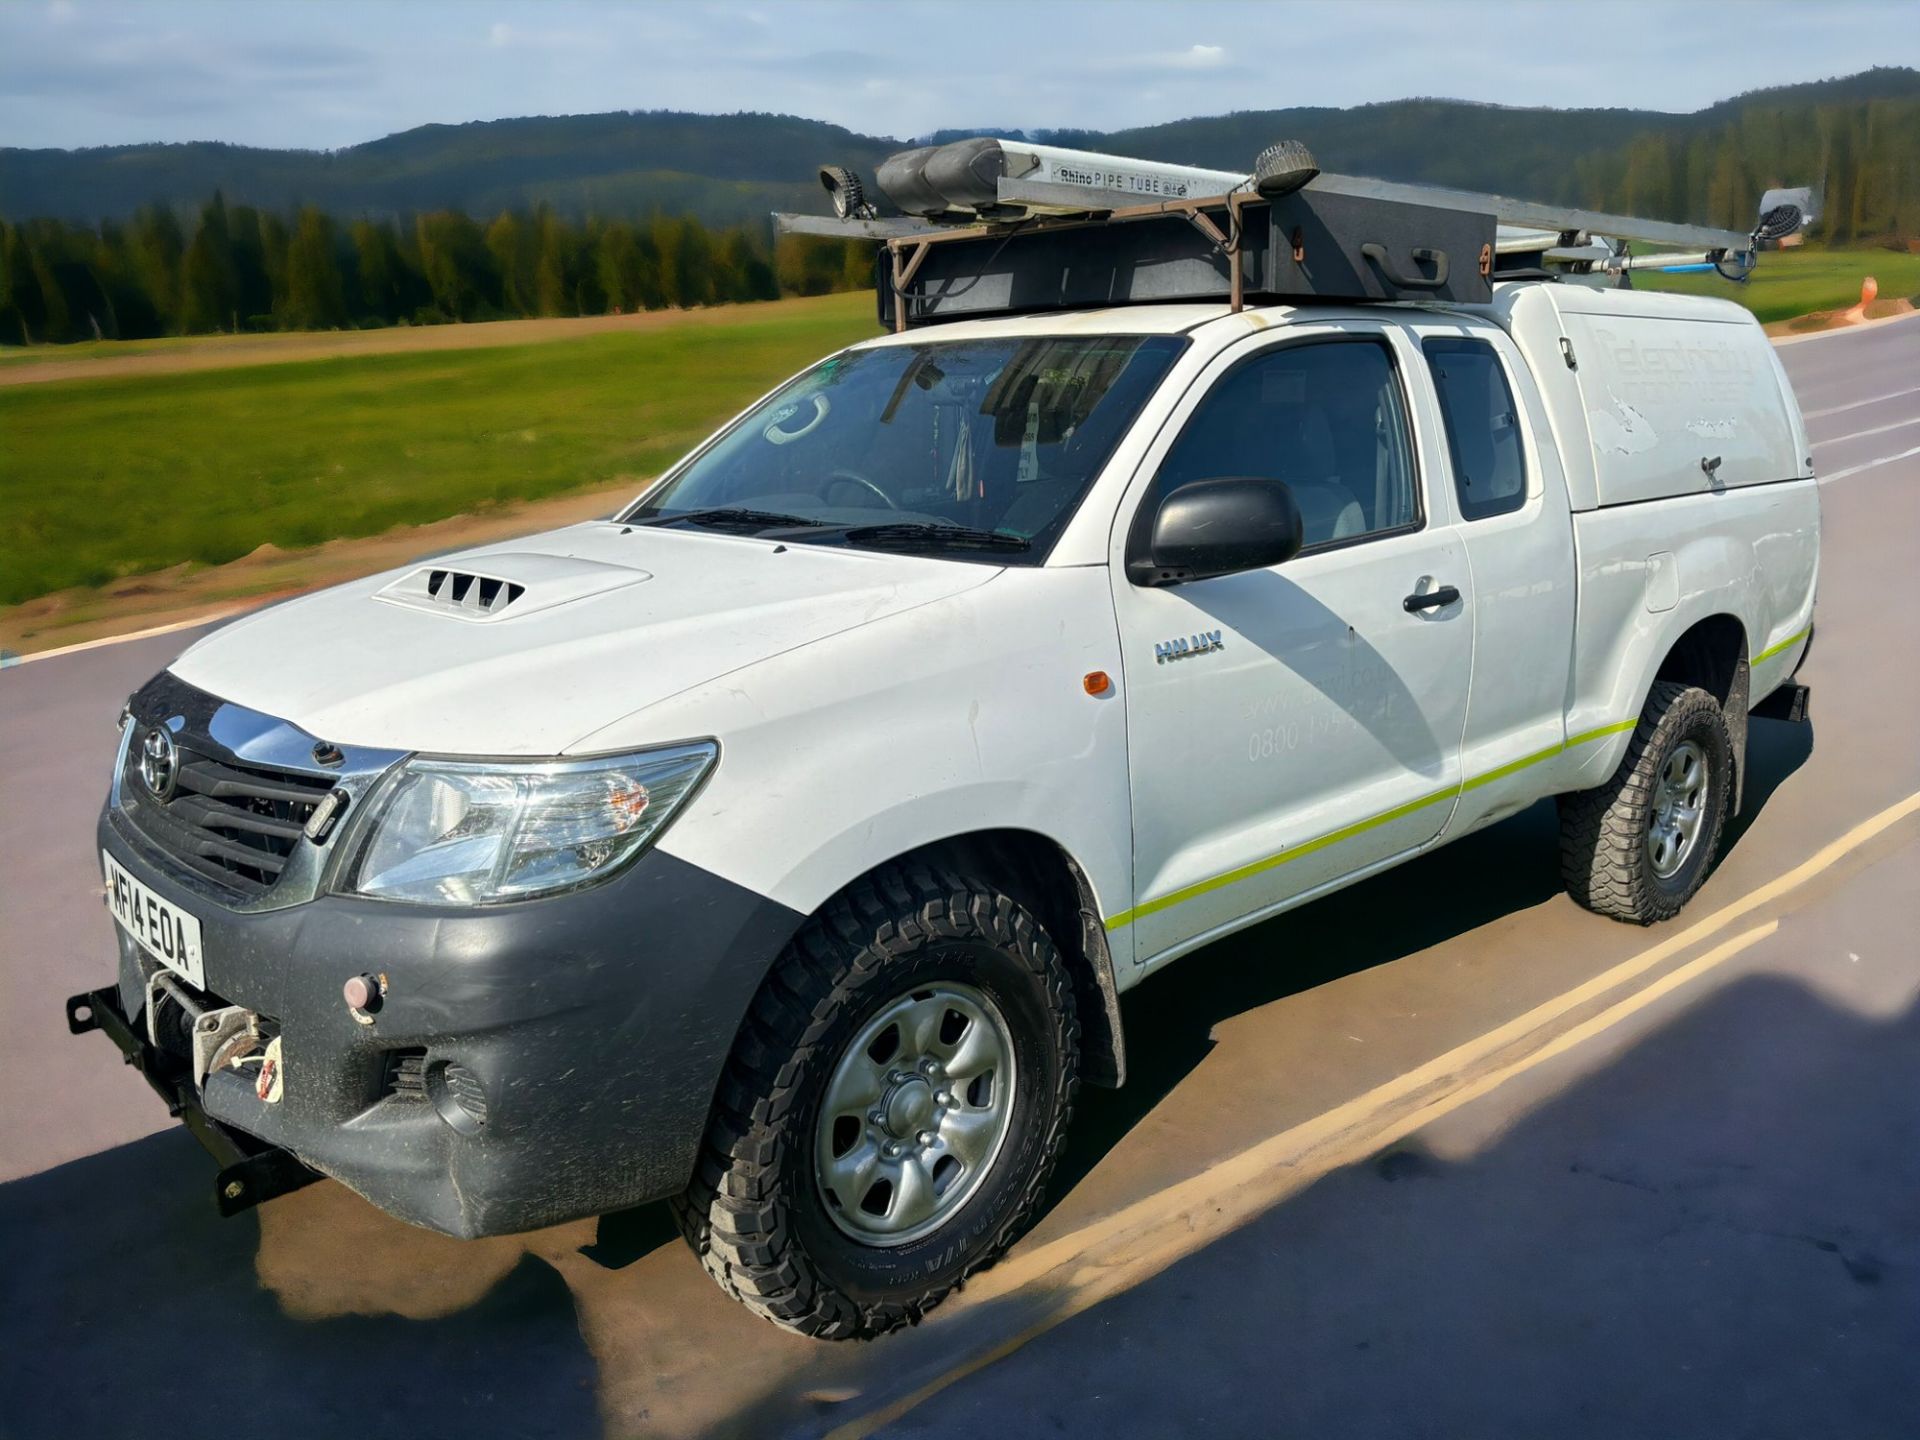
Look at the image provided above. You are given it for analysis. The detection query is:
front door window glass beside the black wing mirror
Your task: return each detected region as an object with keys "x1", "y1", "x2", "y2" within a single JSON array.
[{"x1": 1146, "y1": 340, "x2": 1421, "y2": 549}]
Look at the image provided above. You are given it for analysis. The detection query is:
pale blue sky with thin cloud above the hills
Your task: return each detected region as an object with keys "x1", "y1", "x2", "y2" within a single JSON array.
[{"x1": 0, "y1": 0, "x2": 1920, "y2": 150}]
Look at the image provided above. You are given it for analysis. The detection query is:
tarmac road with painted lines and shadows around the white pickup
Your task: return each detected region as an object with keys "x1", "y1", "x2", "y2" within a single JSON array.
[{"x1": 0, "y1": 319, "x2": 1920, "y2": 1440}]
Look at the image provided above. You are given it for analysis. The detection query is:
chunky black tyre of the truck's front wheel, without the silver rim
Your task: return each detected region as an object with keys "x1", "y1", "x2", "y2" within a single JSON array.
[{"x1": 674, "y1": 864, "x2": 1079, "y2": 1340}]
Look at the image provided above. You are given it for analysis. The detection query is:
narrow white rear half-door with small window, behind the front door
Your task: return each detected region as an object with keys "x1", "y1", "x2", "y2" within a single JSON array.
[{"x1": 1407, "y1": 317, "x2": 1574, "y2": 833}]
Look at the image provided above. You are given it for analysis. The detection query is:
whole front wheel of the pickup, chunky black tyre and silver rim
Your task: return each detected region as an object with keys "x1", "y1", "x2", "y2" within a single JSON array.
[{"x1": 676, "y1": 866, "x2": 1079, "y2": 1340}]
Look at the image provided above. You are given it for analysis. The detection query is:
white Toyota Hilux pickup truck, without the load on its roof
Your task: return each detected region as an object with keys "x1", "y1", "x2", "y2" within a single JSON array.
[{"x1": 69, "y1": 234, "x2": 1820, "y2": 1336}]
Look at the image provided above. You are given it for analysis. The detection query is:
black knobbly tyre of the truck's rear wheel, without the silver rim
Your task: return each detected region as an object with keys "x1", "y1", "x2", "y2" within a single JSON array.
[{"x1": 1559, "y1": 680, "x2": 1734, "y2": 925}]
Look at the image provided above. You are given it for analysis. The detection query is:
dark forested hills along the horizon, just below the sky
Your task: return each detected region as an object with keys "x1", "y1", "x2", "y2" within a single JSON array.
[{"x1": 0, "y1": 67, "x2": 1920, "y2": 234}]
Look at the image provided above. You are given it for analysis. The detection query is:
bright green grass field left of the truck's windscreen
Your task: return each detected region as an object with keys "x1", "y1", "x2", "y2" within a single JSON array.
[{"x1": 0, "y1": 294, "x2": 874, "y2": 605}]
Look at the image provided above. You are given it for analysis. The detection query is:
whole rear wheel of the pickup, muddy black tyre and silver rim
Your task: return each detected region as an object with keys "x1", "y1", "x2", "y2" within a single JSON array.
[{"x1": 1559, "y1": 680, "x2": 1734, "y2": 925}]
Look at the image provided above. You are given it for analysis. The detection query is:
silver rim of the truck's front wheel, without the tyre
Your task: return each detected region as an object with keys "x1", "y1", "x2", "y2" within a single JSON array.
[{"x1": 814, "y1": 981, "x2": 1016, "y2": 1246}]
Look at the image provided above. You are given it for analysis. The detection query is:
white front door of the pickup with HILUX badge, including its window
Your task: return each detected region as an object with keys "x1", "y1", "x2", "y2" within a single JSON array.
[{"x1": 1108, "y1": 323, "x2": 1473, "y2": 962}]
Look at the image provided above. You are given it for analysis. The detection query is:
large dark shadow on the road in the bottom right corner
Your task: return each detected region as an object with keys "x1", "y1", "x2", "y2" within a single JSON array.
[{"x1": 860, "y1": 971, "x2": 1920, "y2": 1440}]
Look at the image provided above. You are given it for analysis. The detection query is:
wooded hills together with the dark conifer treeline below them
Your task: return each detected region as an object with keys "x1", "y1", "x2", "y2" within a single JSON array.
[{"x1": 15, "y1": 67, "x2": 1920, "y2": 353}]
